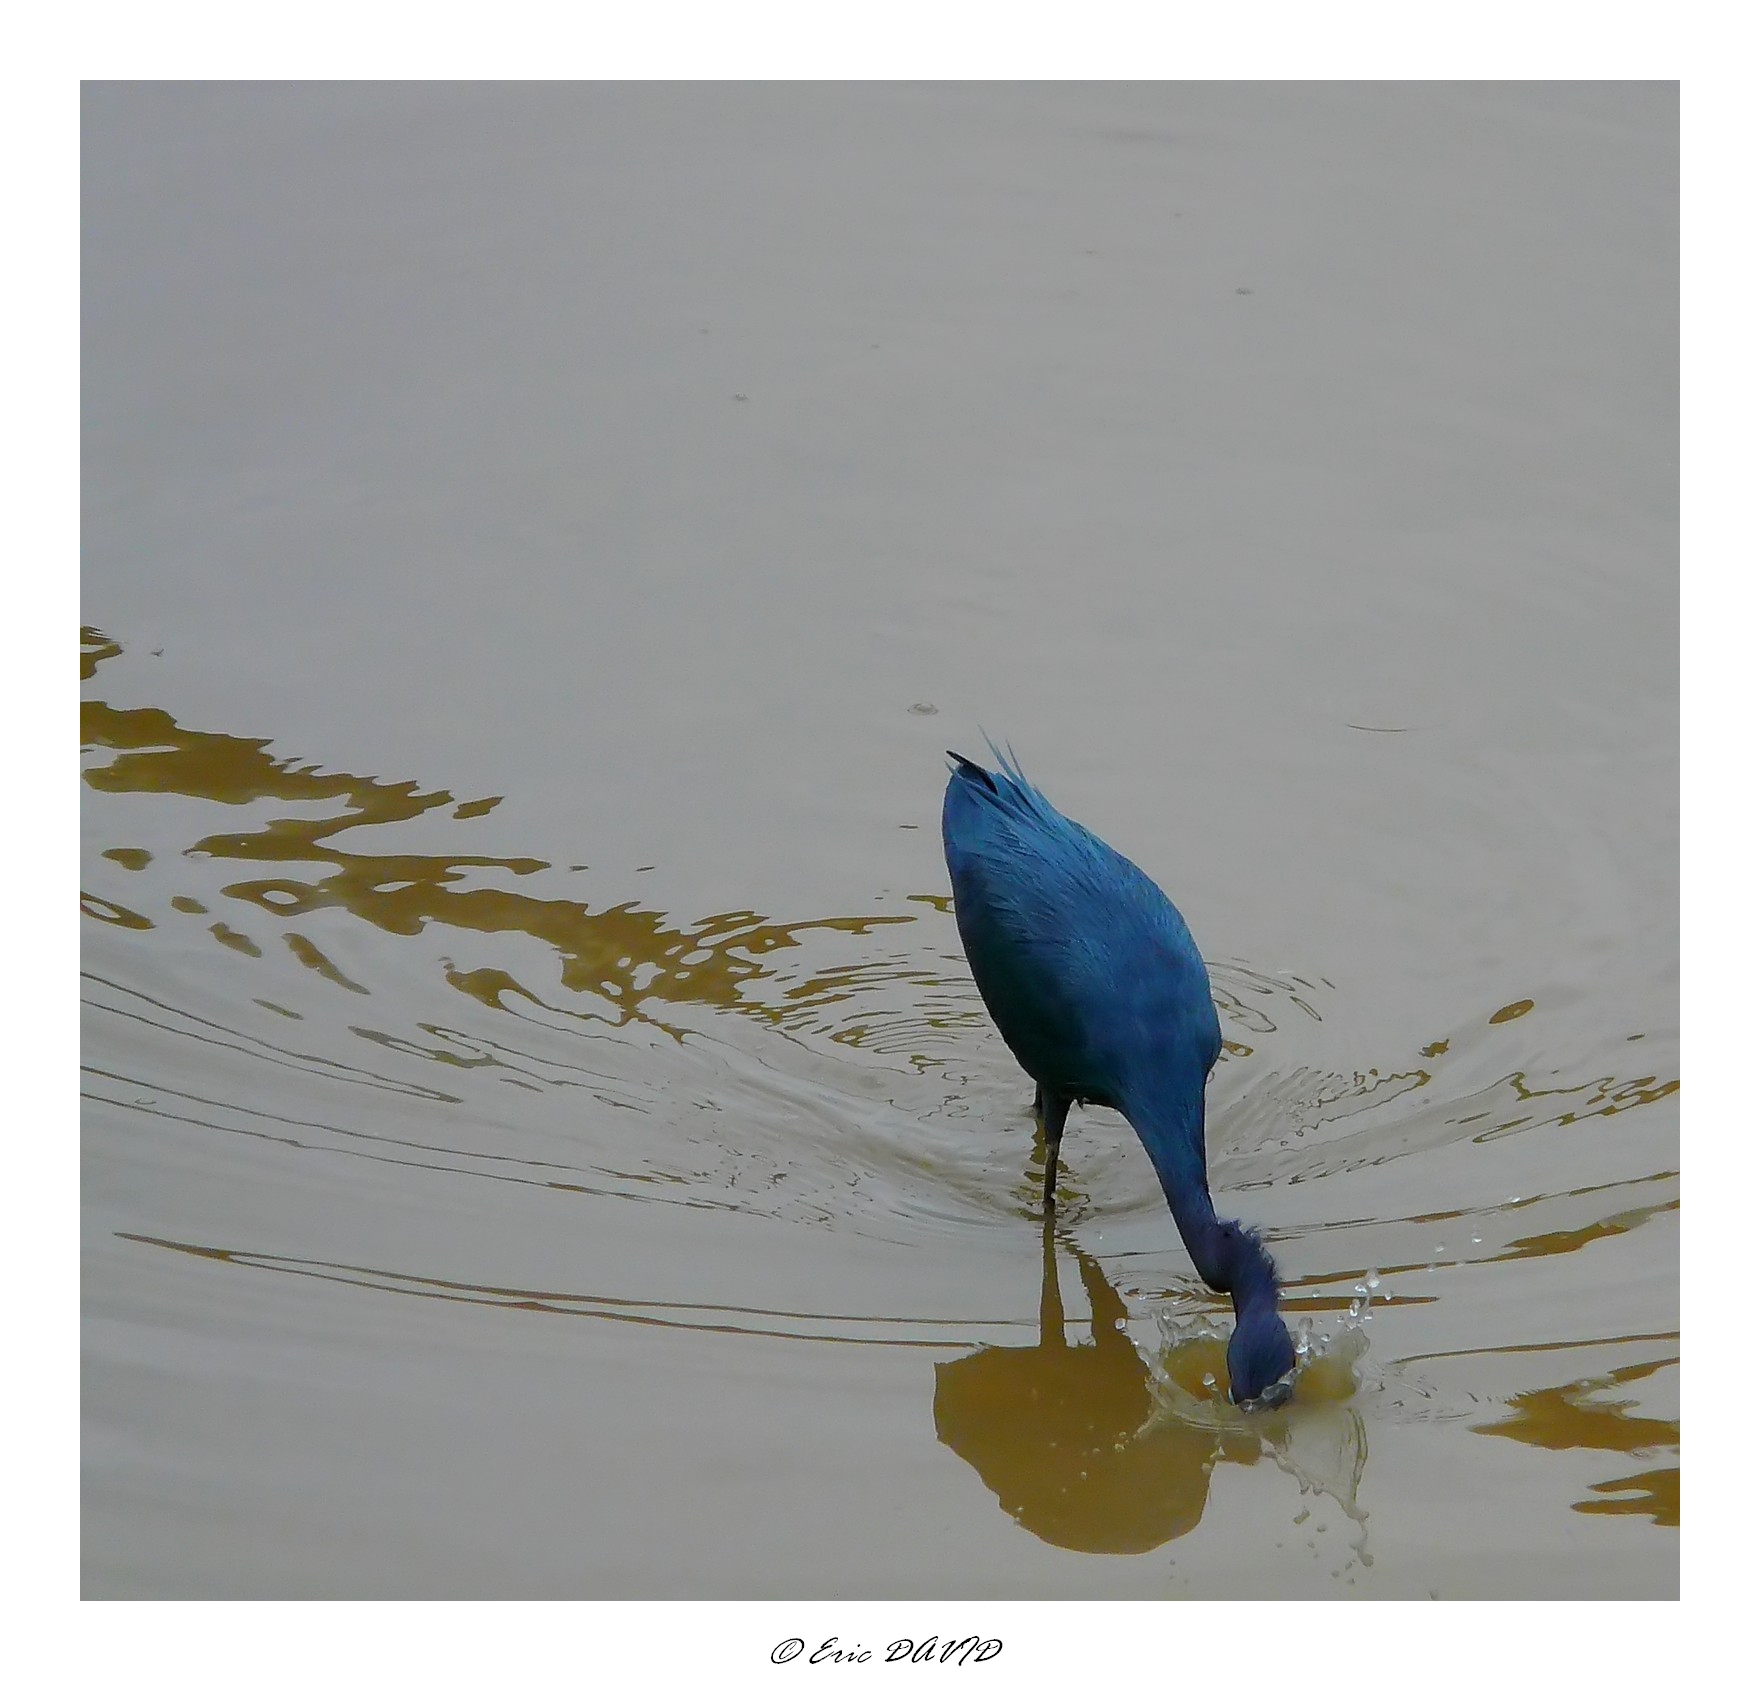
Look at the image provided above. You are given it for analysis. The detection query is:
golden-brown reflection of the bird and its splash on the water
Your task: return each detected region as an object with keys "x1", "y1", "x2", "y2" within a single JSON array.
[{"x1": 935, "y1": 1222, "x2": 1369, "y2": 1563}]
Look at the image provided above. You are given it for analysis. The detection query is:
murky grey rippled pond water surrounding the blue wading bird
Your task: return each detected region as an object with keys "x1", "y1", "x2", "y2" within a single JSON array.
[{"x1": 83, "y1": 86, "x2": 1679, "y2": 1598}]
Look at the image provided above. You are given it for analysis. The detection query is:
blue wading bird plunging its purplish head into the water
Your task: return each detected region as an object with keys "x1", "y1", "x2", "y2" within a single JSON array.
[{"x1": 942, "y1": 753, "x2": 1295, "y2": 1403}]
